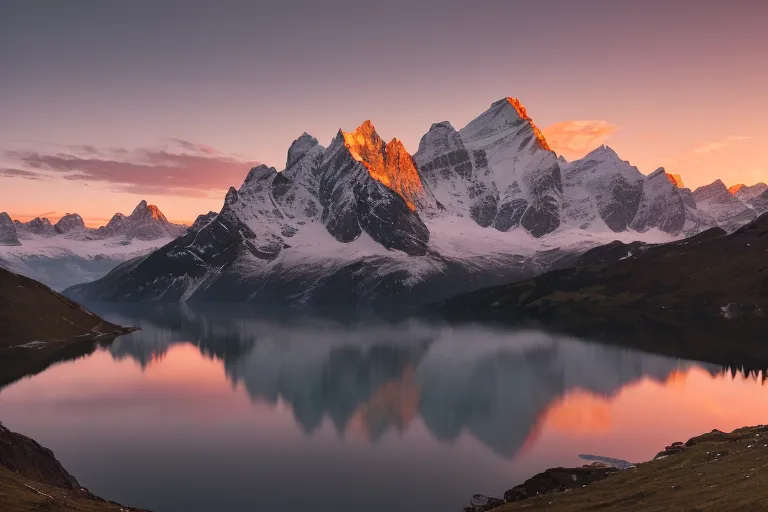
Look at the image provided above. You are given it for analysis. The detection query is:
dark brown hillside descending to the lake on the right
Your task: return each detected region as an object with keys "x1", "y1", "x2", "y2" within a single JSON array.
[{"x1": 436, "y1": 215, "x2": 768, "y2": 364}]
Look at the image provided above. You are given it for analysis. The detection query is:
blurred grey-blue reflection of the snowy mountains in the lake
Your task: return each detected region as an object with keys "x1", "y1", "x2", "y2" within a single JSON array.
[{"x1": 100, "y1": 308, "x2": 722, "y2": 457}]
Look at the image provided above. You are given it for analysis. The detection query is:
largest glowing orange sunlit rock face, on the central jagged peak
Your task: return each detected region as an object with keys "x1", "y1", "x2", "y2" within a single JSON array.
[{"x1": 341, "y1": 121, "x2": 424, "y2": 210}]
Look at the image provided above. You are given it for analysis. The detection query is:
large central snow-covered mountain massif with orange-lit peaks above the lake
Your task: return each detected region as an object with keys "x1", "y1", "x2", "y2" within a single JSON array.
[{"x1": 67, "y1": 98, "x2": 760, "y2": 306}]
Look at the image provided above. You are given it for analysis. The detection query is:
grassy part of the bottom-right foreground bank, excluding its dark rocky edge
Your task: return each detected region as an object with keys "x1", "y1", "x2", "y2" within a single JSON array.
[{"x1": 494, "y1": 427, "x2": 768, "y2": 512}]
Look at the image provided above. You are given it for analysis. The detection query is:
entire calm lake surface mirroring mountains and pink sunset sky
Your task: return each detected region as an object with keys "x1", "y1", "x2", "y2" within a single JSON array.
[{"x1": 0, "y1": 307, "x2": 768, "y2": 512}]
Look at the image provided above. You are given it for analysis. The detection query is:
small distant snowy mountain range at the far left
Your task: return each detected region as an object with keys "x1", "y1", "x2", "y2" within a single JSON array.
[{"x1": 0, "y1": 201, "x2": 186, "y2": 290}]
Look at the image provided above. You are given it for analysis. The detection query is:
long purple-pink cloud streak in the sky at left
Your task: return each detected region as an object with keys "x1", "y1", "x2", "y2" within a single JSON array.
[{"x1": 0, "y1": 139, "x2": 257, "y2": 197}]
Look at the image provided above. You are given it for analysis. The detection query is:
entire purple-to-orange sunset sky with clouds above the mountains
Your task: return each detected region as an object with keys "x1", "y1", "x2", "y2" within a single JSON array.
[{"x1": 0, "y1": 0, "x2": 768, "y2": 225}]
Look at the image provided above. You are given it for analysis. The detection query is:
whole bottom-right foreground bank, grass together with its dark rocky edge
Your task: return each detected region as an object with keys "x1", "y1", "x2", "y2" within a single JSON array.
[{"x1": 464, "y1": 425, "x2": 768, "y2": 512}]
